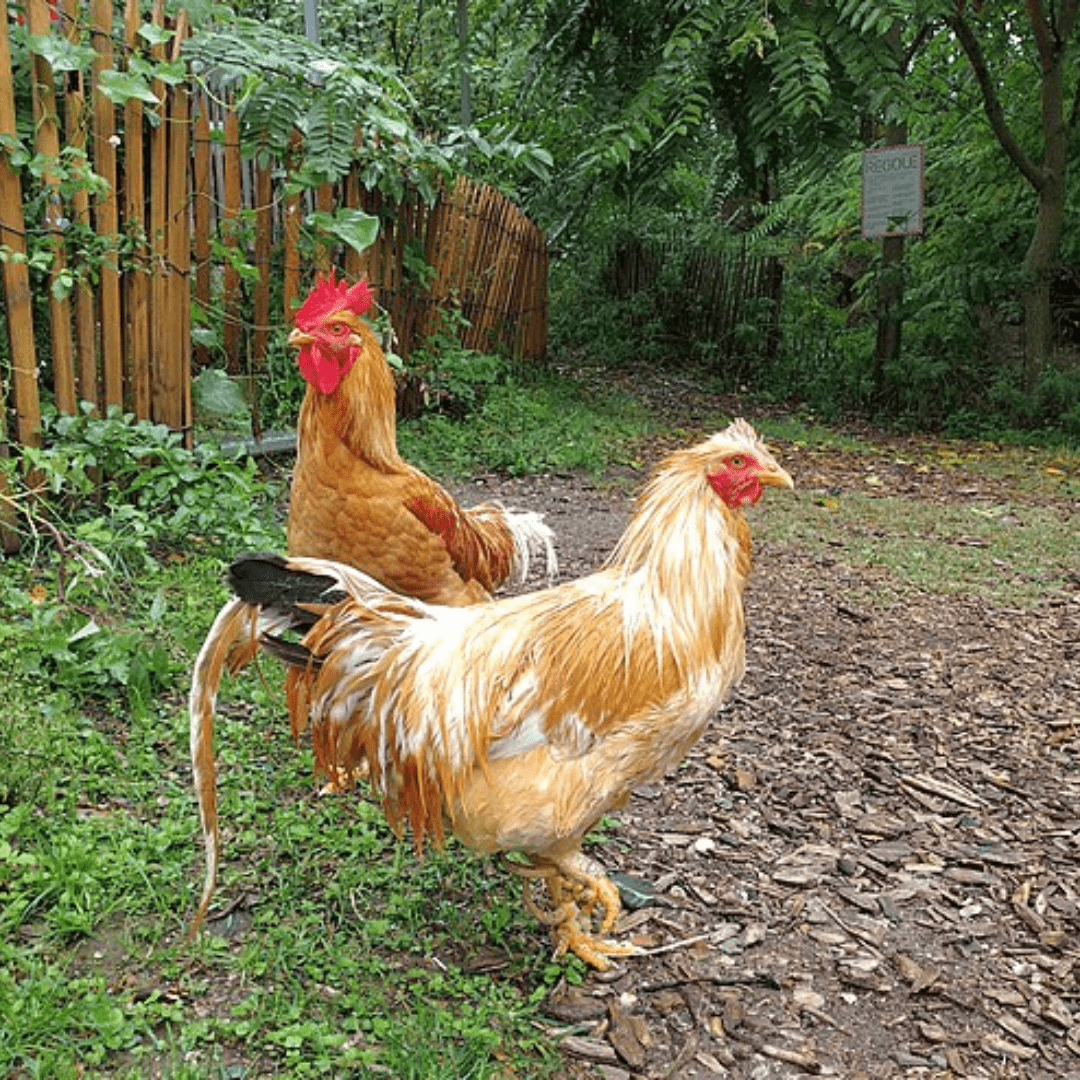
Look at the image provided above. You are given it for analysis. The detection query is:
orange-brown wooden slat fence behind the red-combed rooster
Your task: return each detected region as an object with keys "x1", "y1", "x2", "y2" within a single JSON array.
[{"x1": 0, "y1": 0, "x2": 548, "y2": 453}]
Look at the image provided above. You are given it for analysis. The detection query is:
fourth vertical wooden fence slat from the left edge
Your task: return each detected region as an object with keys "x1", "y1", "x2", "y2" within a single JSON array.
[{"x1": 90, "y1": 0, "x2": 124, "y2": 407}]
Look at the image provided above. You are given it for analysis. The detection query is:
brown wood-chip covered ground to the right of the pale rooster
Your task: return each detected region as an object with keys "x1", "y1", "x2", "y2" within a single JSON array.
[{"x1": 456, "y1": 373, "x2": 1080, "y2": 1080}]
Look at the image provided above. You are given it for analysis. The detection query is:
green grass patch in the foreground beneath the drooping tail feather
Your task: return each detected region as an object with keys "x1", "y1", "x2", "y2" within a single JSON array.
[{"x1": 0, "y1": 558, "x2": 576, "y2": 1078}]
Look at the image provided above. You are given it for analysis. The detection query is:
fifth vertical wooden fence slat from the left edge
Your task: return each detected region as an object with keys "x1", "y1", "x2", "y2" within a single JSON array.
[{"x1": 123, "y1": 0, "x2": 153, "y2": 420}]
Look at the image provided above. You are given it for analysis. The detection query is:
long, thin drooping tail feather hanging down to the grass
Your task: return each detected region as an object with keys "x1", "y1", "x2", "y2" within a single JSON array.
[{"x1": 188, "y1": 599, "x2": 258, "y2": 941}]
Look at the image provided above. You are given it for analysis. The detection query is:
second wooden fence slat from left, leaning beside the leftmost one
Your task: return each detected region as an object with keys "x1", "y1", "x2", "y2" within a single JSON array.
[{"x1": 26, "y1": 0, "x2": 76, "y2": 415}]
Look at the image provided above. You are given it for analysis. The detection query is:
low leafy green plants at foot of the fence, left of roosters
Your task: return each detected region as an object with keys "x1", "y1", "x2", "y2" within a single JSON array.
[{"x1": 0, "y1": 410, "x2": 283, "y2": 718}]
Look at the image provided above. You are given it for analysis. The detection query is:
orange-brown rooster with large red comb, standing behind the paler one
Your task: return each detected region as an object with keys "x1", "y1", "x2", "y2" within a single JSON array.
[{"x1": 288, "y1": 273, "x2": 557, "y2": 605}]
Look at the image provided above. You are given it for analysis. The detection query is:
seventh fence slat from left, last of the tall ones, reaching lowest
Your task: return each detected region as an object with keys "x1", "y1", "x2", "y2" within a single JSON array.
[{"x1": 165, "y1": 8, "x2": 194, "y2": 438}]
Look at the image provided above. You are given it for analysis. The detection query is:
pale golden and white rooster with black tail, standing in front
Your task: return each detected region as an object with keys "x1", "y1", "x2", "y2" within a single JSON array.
[{"x1": 190, "y1": 420, "x2": 794, "y2": 970}]
